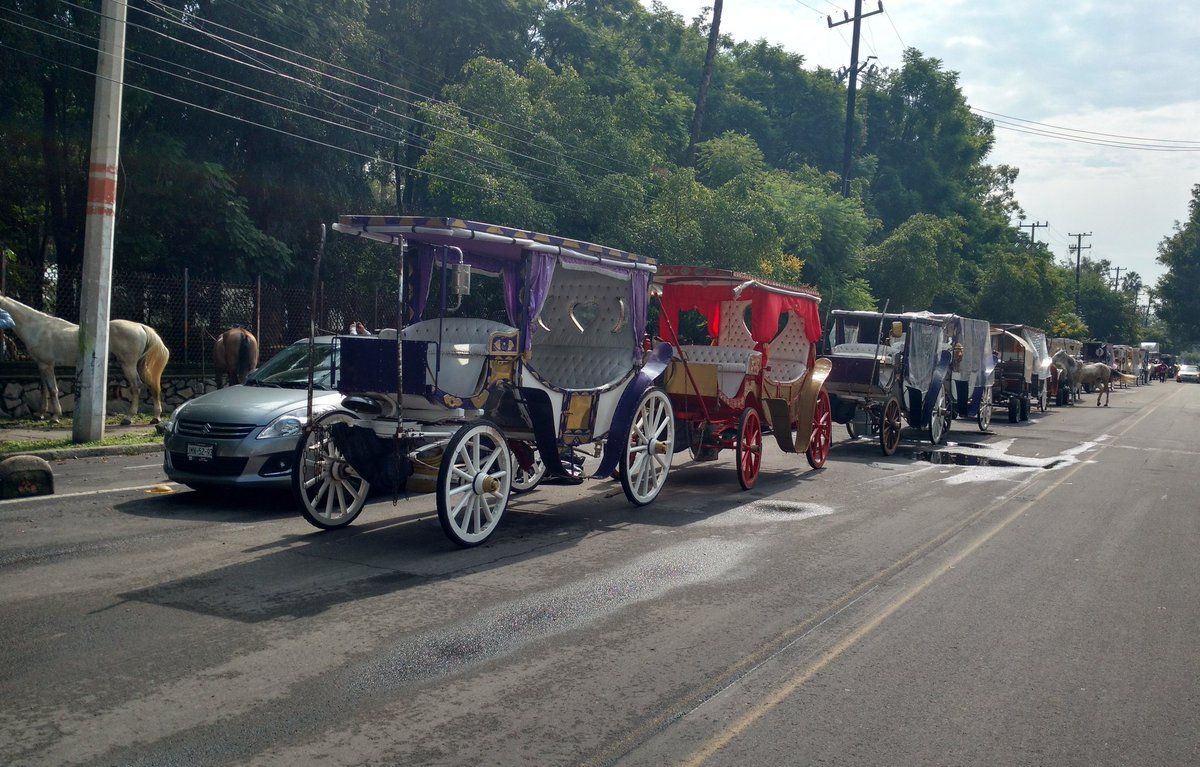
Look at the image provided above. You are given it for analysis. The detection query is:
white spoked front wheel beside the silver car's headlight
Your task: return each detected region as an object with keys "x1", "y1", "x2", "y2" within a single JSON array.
[{"x1": 292, "y1": 413, "x2": 371, "y2": 531}]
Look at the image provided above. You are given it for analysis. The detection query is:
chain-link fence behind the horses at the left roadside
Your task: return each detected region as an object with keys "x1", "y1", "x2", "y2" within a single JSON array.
[{"x1": 0, "y1": 264, "x2": 396, "y2": 370}]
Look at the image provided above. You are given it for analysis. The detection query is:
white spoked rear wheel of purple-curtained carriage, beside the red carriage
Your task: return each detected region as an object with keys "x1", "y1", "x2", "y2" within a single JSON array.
[{"x1": 620, "y1": 388, "x2": 674, "y2": 507}]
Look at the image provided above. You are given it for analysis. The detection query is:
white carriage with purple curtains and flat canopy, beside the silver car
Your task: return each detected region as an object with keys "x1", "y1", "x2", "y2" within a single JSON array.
[{"x1": 293, "y1": 216, "x2": 674, "y2": 546}]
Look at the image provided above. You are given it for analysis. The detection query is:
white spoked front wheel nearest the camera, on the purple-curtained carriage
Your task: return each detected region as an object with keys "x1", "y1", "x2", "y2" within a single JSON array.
[{"x1": 438, "y1": 421, "x2": 514, "y2": 547}]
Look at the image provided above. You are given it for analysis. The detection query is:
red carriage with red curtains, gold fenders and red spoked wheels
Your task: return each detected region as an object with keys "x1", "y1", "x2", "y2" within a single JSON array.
[{"x1": 654, "y1": 266, "x2": 833, "y2": 490}]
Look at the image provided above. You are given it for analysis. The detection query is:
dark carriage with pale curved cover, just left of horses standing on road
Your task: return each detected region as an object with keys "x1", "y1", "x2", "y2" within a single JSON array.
[{"x1": 991, "y1": 325, "x2": 1055, "y2": 424}]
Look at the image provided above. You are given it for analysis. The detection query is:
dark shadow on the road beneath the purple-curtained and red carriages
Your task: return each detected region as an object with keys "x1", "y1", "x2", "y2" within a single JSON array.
[{"x1": 112, "y1": 468, "x2": 787, "y2": 623}]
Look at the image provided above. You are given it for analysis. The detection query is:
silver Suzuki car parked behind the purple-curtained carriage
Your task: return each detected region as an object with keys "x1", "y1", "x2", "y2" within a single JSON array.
[{"x1": 163, "y1": 336, "x2": 342, "y2": 489}]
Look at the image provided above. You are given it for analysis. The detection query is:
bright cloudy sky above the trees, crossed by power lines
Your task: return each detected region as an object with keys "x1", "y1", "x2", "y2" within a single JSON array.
[{"x1": 644, "y1": 0, "x2": 1200, "y2": 283}]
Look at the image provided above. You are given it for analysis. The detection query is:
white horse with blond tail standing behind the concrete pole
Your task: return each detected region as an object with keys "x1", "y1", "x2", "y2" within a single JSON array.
[{"x1": 0, "y1": 295, "x2": 170, "y2": 424}]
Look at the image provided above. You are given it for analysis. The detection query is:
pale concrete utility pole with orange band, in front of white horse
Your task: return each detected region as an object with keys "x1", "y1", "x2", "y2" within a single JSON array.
[{"x1": 71, "y1": 0, "x2": 128, "y2": 442}]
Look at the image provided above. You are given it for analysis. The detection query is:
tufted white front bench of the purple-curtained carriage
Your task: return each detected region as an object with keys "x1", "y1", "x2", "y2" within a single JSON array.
[{"x1": 403, "y1": 317, "x2": 516, "y2": 396}]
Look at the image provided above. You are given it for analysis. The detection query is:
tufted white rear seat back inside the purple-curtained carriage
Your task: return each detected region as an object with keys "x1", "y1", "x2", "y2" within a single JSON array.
[{"x1": 528, "y1": 265, "x2": 636, "y2": 390}]
